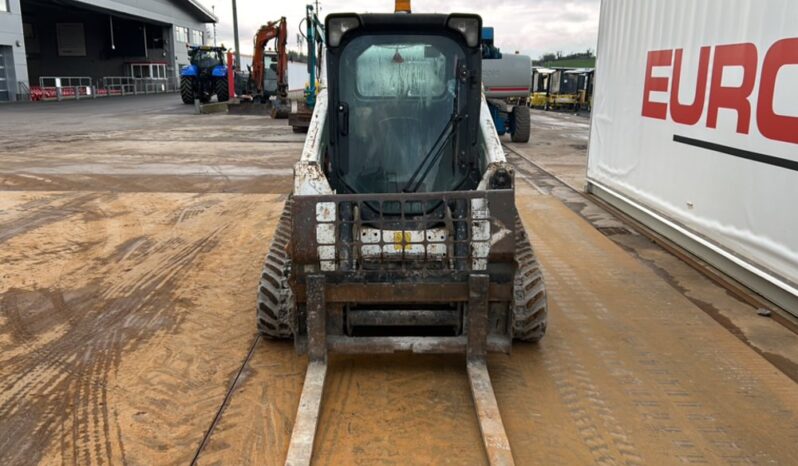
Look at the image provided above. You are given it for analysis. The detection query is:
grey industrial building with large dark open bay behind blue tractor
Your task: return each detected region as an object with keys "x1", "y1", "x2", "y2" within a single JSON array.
[{"x1": 0, "y1": 0, "x2": 217, "y2": 102}]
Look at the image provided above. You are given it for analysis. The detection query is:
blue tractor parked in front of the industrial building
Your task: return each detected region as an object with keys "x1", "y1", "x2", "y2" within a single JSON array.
[{"x1": 180, "y1": 45, "x2": 230, "y2": 104}]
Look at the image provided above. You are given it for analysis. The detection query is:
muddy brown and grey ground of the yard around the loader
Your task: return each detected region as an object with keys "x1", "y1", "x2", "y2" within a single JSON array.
[{"x1": 0, "y1": 96, "x2": 798, "y2": 465}]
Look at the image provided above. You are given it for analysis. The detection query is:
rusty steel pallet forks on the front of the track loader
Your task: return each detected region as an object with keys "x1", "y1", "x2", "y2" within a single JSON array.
[{"x1": 285, "y1": 273, "x2": 515, "y2": 466}]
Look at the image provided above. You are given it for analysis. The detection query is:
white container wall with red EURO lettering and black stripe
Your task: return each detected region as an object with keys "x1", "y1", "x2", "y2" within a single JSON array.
[{"x1": 588, "y1": 0, "x2": 798, "y2": 313}]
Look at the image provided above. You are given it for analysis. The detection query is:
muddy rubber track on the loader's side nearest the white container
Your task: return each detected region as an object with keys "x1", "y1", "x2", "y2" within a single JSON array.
[{"x1": 513, "y1": 217, "x2": 548, "y2": 343}]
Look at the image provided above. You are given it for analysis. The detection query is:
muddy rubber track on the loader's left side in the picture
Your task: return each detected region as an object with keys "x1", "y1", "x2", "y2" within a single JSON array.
[{"x1": 258, "y1": 196, "x2": 296, "y2": 338}]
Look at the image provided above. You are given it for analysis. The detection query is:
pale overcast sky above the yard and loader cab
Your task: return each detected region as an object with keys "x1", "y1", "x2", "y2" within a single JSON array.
[{"x1": 201, "y1": 0, "x2": 600, "y2": 58}]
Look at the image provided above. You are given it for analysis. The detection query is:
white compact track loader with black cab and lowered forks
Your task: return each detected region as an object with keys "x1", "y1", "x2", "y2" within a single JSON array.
[{"x1": 257, "y1": 1, "x2": 547, "y2": 464}]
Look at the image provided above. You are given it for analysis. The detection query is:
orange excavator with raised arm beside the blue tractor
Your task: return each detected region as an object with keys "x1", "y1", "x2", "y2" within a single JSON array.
[{"x1": 248, "y1": 16, "x2": 291, "y2": 118}]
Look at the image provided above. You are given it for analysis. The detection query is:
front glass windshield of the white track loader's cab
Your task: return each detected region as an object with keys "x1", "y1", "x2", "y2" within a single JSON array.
[{"x1": 339, "y1": 35, "x2": 466, "y2": 193}]
